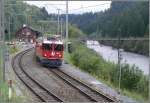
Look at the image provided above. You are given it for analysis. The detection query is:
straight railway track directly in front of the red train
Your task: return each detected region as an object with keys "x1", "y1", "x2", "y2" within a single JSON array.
[{"x1": 50, "y1": 68, "x2": 115, "y2": 102}]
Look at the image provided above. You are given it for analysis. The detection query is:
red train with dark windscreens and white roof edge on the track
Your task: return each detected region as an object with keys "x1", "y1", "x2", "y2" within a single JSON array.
[{"x1": 35, "y1": 37, "x2": 64, "y2": 67}]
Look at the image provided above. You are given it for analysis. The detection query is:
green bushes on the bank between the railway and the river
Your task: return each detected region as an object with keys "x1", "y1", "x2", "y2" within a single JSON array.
[{"x1": 67, "y1": 42, "x2": 148, "y2": 101}]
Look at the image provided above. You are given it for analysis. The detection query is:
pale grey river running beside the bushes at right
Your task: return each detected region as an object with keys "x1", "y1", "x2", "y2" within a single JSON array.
[{"x1": 87, "y1": 40, "x2": 149, "y2": 74}]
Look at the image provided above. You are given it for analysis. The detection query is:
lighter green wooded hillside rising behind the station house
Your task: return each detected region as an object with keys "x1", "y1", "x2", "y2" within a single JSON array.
[{"x1": 5, "y1": 0, "x2": 83, "y2": 39}]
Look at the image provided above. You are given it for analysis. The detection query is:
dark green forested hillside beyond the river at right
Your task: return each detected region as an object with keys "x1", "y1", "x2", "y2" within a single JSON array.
[{"x1": 69, "y1": 1, "x2": 149, "y2": 37}]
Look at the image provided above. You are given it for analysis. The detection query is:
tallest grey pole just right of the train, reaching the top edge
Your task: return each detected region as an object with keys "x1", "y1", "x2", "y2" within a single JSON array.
[{"x1": 66, "y1": 0, "x2": 68, "y2": 52}]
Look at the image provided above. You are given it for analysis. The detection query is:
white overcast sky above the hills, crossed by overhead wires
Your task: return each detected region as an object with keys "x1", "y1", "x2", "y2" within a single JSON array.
[{"x1": 26, "y1": 1, "x2": 111, "y2": 14}]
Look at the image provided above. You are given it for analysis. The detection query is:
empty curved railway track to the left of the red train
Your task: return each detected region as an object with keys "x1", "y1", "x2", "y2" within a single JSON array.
[{"x1": 12, "y1": 49, "x2": 63, "y2": 102}]
